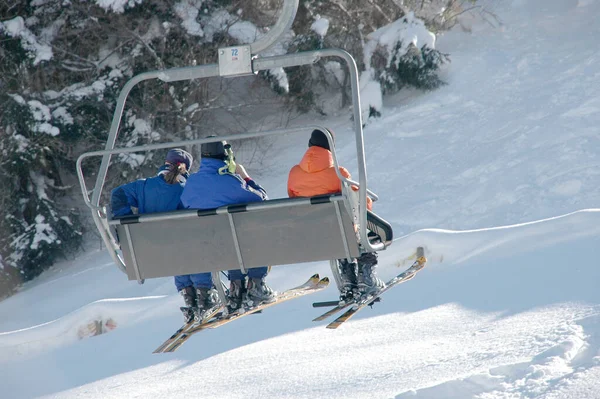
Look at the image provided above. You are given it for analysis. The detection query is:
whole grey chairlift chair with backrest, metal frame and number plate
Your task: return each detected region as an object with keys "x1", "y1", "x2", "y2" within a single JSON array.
[{"x1": 77, "y1": 0, "x2": 393, "y2": 295}]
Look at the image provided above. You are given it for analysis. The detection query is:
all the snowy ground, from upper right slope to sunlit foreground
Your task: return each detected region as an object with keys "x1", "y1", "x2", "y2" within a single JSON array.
[{"x1": 0, "y1": 0, "x2": 600, "y2": 399}]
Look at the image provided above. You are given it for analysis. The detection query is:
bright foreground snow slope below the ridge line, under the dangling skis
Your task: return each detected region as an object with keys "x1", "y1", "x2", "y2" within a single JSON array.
[{"x1": 0, "y1": 211, "x2": 600, "y2": 398}]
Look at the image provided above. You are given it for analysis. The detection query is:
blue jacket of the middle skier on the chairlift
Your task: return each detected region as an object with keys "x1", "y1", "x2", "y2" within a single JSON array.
[{"x1": 181, "y1": 158, "x2": 268, "y2": 209}]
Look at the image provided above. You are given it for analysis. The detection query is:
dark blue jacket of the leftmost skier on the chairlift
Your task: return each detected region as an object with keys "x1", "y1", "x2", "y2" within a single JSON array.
[{"x1": 110, "y1": 167, "x2": 183, "y2": 217}]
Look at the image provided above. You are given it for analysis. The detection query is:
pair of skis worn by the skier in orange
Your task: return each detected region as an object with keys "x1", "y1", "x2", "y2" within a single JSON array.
[{"x1": 313, "y1": 247, "x2": 427, "y2": 329}]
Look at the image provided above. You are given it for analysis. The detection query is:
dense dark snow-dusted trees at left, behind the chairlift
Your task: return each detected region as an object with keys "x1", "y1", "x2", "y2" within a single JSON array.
[{"x1": 0, "y1": 0, "x2": 288, "y2": 296}]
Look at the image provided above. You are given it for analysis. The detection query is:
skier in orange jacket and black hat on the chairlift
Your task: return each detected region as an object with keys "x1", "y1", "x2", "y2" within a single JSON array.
[{"x1": 287, "y1": 130, "x2": 385, "y2": 300}]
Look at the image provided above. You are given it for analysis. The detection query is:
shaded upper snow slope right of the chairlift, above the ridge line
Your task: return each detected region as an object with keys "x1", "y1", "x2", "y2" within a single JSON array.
[{"x1": 366, "y1": 0, "x2": 600, "y2": 233}]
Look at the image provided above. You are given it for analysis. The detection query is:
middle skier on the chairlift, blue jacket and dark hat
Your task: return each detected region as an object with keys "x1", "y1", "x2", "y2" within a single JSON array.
[{"x1": 181, "y1": 141, "x2": 274, "y2": 318}]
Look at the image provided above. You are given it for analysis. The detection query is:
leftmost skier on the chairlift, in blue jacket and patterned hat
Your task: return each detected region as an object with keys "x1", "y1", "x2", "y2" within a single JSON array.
[{"x1": 111, "y1": 148, "x2": 210, "y2": 322}]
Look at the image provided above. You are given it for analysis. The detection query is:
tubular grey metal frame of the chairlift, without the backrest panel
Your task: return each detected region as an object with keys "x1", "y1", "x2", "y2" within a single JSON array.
[{"x1": 77, "y1": 0, "x2": 389, "y2": 291}]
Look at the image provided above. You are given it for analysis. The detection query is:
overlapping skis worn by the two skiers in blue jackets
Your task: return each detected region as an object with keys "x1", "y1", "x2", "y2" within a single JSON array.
[{"x1": 153, "y1": 274, "x2": 329, "y2": 353}]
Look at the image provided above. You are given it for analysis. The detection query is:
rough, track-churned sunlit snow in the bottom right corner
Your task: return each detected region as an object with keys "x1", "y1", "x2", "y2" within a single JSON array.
[{"x1": 396, "y1": 314, "x2": 600, "y2": 399}]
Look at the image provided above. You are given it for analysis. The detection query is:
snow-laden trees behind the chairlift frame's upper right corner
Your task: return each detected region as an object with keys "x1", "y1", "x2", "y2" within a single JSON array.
[{"x1": 288, "y1": 0, "x2": 449, "y2": 117}]
